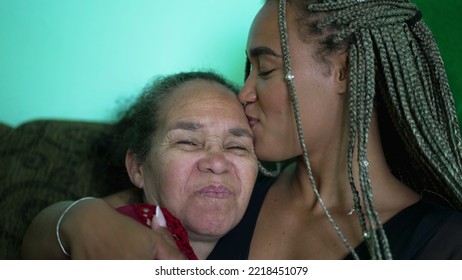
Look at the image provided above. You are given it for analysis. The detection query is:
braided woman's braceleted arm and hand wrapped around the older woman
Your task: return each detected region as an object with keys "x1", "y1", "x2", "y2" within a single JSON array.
[{"x1": 22, "y1": 190, "x2": 185, "y2": 259}]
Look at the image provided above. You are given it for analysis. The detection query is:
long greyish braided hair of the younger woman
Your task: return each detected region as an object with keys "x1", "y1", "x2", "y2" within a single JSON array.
[{"x1": 266, "y1": 0, "x2": 462, "y2": 259}]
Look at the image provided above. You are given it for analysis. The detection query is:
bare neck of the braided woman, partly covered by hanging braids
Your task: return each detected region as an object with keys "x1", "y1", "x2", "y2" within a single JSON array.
[{"x1": 290, "y1": 110, "x2": 399, "y2": 211}]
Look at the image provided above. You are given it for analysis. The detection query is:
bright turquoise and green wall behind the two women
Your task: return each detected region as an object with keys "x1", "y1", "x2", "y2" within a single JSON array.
[{"x1": 0, "y1": 0, "x2": 462, "y2": 125}]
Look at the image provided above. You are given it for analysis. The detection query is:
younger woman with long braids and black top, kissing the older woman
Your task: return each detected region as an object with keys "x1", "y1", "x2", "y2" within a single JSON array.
[{"x1": 22, "y1": 0, "x2": 462, "y2": 259}]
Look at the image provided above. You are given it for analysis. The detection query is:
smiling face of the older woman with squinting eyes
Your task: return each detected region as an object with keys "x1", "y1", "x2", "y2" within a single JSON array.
[{"x1": 142, "y1": 80, "x2": 258, "y2": 241}]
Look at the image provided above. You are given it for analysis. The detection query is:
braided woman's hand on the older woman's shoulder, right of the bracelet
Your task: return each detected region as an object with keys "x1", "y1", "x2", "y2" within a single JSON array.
[{"x1": 61, "y1": 199, "x2": 186, "y2": 259}]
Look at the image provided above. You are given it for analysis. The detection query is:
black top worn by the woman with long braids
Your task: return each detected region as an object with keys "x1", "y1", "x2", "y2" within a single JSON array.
[{"x1": 208, "y1": 176, "x2": 462, "y2": 260}]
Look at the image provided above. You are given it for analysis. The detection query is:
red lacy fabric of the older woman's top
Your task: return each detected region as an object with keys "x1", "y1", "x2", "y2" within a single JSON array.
[{"x1": 117, "y1": 203, "x2": 197, "y2": 260}]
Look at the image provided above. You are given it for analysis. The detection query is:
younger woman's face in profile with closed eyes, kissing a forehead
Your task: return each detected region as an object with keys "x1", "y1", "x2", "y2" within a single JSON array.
[{"x1": 239, "y1": 1, "x2": 348, "y2": 161}]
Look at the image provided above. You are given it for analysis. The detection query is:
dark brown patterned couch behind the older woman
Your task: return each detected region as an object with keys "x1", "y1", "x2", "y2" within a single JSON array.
[{"x1": 0, "y1": 120, "x2": 122, "y2": 259}]
